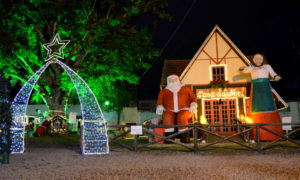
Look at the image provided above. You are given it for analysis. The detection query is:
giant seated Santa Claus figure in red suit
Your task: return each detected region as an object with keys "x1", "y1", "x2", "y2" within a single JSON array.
[{"x1": 156, "y1": 75, "x2": 197, "y2": 142}]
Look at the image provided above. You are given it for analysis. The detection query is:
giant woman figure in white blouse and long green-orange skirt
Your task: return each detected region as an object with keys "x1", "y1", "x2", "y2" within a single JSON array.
[{"x1": 239, "y1": 54, "x2": 283, "y2": 141}]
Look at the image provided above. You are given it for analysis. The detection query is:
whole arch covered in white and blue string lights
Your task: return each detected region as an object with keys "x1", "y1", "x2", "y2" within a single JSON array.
[{"x1": 11, "y1": 59, "x2": 109, "y2": 155}]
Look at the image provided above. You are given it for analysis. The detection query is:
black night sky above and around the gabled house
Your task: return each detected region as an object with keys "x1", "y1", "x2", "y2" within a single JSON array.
[{"x1": 139, "y1": 0, "x2": 300, "y2": 100}]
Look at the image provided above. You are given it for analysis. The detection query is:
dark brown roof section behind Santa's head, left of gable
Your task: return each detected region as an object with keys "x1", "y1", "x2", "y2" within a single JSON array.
[{"x1": 160, "y1": 59, "x2": 190, "y2": 86}]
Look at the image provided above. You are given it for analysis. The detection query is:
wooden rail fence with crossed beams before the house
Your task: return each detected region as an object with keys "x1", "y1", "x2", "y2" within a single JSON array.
[{"x1": 109, "y1": 123, "x2": 300, "y2": 152}]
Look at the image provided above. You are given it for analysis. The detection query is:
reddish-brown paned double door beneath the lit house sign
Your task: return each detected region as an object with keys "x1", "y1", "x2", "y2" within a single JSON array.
[{"x1": 204, "y1": 99, "x2": 237, "y2": 134}]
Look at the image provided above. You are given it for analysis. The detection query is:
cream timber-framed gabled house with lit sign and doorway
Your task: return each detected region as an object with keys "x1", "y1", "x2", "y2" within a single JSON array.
[{"x1": 161, "y1": 26, "x2": 287, "y2": 134}]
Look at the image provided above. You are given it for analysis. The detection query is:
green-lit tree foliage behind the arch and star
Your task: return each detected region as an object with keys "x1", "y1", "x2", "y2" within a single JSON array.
[{"x1": 0, "y1": 0, "x2": 169, "y2": 112}]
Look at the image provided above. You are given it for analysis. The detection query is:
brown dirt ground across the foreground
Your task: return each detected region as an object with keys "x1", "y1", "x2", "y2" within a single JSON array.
[{"x1": 0, "y1": 145, "x2": 300, "y2": 180}]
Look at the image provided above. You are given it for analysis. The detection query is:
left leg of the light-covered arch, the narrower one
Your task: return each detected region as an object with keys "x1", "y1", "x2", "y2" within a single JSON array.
[{"x1": 10, "y1": 61, "x2": 52, "y2": 153}]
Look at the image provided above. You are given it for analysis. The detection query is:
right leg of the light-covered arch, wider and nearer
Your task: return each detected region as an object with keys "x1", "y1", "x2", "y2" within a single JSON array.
[{"x1": 55, "y1": 60, "x2": 109, "y2": 155}]
